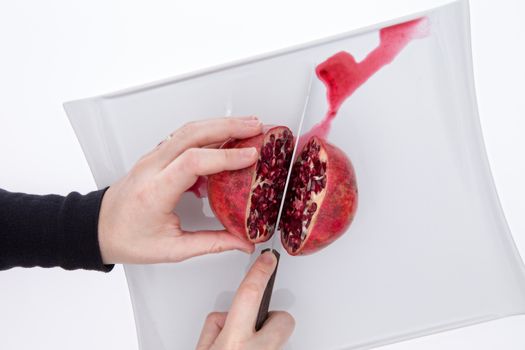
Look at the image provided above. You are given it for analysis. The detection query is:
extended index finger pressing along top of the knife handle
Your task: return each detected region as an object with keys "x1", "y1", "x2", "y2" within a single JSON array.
[{"x1": 225, "y1": 252, "x2": 277, "y2": 337}]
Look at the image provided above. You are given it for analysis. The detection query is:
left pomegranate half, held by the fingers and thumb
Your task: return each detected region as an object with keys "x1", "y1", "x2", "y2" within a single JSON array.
[{"x1": 208, "y1": 126, "x2": 294, "y2": 243}]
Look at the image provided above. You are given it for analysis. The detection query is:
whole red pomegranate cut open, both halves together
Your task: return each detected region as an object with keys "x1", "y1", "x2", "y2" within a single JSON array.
[{"x1": 208, "y1": 126, "x2": 357, "y2": 255}]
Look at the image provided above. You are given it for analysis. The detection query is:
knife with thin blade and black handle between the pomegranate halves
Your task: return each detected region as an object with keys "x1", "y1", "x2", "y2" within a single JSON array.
[{"x1": 255, "y1": 69, "x2": 314, "y2": 331}]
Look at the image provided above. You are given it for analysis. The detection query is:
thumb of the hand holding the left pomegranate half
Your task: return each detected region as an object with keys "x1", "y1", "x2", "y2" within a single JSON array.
[{"x1": 173, "y1": 231, "x2": 254, "y2": 261}]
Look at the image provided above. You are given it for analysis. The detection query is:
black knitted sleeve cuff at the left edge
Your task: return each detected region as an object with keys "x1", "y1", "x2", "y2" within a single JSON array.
[{"x1": 0, "y1": 189, "x2": 113, "y2": 272}]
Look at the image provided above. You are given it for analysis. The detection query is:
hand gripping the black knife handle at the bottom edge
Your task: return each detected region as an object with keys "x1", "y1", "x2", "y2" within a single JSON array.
[{"x1": 197, "y1": 252, "x2": 295, "y2": 350}]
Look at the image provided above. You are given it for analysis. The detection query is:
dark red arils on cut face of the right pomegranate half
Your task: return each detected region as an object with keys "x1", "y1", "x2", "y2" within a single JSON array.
[{"x1": 280, "y1": 138, "x2": 326, "y2": 253}]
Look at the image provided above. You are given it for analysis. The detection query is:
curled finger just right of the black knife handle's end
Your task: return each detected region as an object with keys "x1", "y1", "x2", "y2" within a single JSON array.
[{"x1": 257, "y1": 311, "x2": 295, "y2": 349}]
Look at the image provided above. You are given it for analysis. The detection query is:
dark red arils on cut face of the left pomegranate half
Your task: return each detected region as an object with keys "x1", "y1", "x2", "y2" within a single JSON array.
[{"x1": 246, "y1": 130, "x2": 293, "y2": 240}]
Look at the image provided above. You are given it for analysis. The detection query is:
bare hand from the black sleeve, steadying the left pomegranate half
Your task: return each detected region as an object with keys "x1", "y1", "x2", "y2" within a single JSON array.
[{"x1": 98, "y1": 117, "x2": 262, "y2": 264}]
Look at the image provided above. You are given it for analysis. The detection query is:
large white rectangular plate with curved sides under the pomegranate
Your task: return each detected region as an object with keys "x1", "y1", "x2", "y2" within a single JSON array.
[{"x1": 65, "y1": 1, "x2": 525, "y2": 350}]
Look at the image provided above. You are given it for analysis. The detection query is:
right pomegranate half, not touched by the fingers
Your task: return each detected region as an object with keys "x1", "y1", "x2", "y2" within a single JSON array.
[{"x1": 279, "y1": 136, "x2": 357, "y2": 255}]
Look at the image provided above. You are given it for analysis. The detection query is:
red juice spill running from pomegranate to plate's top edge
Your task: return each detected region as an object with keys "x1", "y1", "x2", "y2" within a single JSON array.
[{"x1": 298, "y1": 17, "x2": 428, "y2": 149}]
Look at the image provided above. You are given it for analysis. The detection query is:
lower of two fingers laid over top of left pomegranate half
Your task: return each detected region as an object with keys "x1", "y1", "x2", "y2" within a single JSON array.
[{"x1": 158, "y1": 147, "x2": 258, "y2": 205}]
